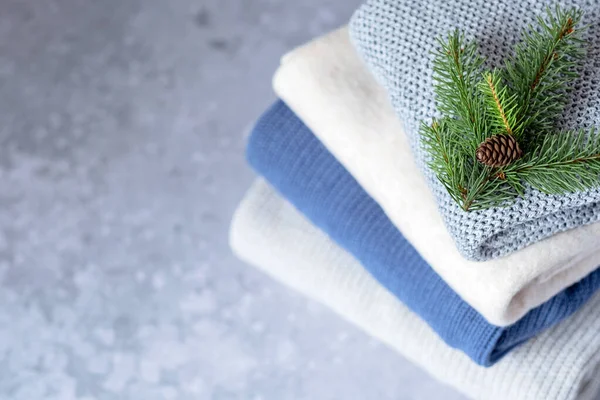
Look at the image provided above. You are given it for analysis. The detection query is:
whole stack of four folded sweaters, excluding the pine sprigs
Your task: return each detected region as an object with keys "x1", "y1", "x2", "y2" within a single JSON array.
[{"x1": 231, "y1": 0, "x2": 600, "y2": 400}]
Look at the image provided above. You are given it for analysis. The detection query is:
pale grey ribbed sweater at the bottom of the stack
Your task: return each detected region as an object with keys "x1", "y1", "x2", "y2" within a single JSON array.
[{"x1": 230, "y1": 181, "x2": 600, "y2": 400}]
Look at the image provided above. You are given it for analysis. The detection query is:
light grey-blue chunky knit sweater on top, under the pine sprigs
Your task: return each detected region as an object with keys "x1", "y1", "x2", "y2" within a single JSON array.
[{"x1": 350, "y1": 0, "x2": 600, "y2": 260}]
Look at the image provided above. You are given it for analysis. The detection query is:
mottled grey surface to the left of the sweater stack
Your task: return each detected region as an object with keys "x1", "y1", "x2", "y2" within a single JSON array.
[{"x1": 0, "y1": 0, "x2": 461, "y2": 400}]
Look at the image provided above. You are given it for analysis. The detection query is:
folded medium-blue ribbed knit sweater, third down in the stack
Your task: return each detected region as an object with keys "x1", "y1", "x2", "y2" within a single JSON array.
[{"x1": 247, "y1": 101, "x2": 600, "y2": 366}]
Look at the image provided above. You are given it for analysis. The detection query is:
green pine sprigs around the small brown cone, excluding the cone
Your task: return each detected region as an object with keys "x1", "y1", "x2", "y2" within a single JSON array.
[{"x1": 421, "y1": 6, "x2": 600, "y2": 211}]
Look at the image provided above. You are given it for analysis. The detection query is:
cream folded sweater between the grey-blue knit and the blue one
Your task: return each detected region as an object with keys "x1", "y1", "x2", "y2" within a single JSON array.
[{"x1": 273, "y1": 29, "x2": 600, "y2": 326}]
